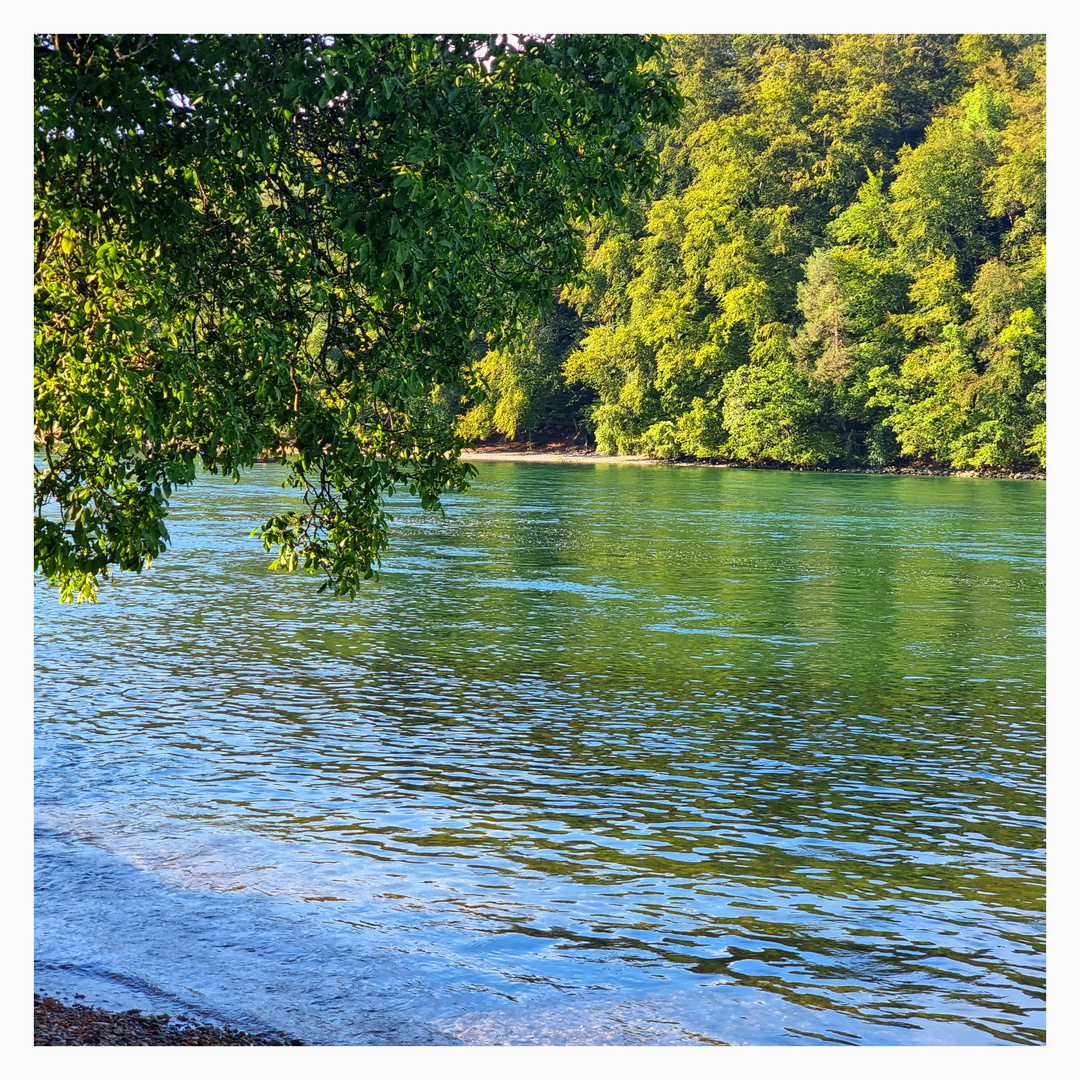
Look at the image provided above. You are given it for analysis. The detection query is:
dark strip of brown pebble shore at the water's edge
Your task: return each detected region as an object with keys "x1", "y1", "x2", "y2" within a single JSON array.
[{"x1": 33, "y1": 994, "x2": 303, "y2": 1047}]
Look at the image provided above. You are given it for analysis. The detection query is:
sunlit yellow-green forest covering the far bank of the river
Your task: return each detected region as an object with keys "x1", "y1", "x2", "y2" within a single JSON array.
[{"x1": 457, "y1": 35, "x2": 1047, "y2": 469}]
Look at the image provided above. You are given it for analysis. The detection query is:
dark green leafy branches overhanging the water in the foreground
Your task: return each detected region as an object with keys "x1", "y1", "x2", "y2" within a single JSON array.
[{"x1": 35, "y1": 35, "x2": 679, "y2": 599}]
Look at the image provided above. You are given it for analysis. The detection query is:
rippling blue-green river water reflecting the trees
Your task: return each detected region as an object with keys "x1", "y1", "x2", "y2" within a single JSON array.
[{"x1": 35, "y1": 462, "x2": 1045, "y2": 1044}]
